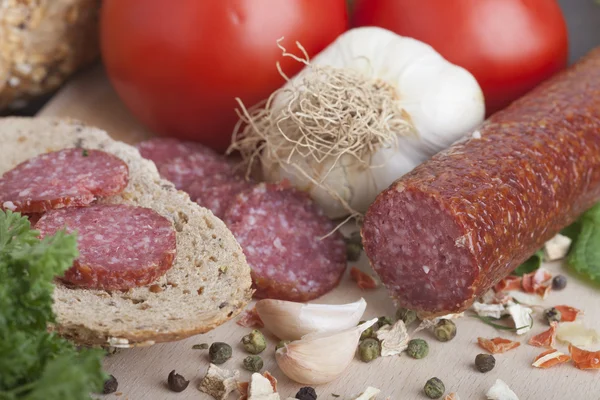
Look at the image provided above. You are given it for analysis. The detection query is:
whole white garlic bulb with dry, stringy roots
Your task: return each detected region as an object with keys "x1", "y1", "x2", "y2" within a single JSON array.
[{"x1": 234, "y1": 27, "x2": 485, "y2": 218}]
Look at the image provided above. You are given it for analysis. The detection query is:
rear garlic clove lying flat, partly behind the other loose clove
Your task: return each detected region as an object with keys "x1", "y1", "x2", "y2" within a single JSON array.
[{"x1": 256, "y1": 298, "x2": 367, "y2": 340}]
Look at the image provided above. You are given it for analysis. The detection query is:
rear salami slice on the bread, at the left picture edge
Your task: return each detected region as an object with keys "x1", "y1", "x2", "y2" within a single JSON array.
[{"x1": 0, "y1": 148, "x2": 129, "y2": 214}]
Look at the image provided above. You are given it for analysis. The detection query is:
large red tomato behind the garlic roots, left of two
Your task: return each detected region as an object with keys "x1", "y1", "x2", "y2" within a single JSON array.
[{"x1": 101, "y1": 0, "x2": 348, "y2": 151}]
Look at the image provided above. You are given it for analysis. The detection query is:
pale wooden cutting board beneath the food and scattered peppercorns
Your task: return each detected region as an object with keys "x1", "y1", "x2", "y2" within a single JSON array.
[{"x1": 39, "y1": 68, "x2": 600, "y2": 400}]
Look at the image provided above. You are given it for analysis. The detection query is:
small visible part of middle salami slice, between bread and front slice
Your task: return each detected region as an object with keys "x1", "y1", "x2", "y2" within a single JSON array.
[{"x1": 187, "y1": 174, "x2": 254, "y2": 219}]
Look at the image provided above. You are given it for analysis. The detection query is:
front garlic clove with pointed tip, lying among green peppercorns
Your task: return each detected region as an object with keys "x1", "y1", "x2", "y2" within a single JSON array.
[{"x1": 275, "y1": 318, "x2": 377, "y2": 385}]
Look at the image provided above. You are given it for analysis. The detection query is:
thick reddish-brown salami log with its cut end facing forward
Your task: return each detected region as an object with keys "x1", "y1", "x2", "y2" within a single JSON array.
[{"x1": 362, "y1": 49, "x2": 600, "y2": 316}]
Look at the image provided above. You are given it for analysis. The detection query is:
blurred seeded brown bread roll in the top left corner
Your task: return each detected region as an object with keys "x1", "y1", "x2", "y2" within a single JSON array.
[{"x1": 0, "y1": 0, "x2": 100, "y2": 109}]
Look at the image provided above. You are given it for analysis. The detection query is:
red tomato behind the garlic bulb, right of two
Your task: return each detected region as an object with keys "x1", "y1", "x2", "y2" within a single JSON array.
[{"x1": 353, "y1": 0, "x2": 568, "y2": 115}]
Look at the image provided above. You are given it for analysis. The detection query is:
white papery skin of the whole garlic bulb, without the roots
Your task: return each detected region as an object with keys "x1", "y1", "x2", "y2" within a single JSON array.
[{"x1": 251, "y1": 27, "x2": 485, "y2": 218}]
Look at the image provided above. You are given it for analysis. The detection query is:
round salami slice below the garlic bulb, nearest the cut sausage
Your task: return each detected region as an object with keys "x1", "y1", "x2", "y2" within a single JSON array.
[{"x1": 224, "y1": 183, "x2": 346, "y2": 301}]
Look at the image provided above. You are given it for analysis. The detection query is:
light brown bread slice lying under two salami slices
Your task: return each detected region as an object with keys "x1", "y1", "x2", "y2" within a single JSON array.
[{"x1": 0, "y1": 118, "x2": 252, "y2": 347}]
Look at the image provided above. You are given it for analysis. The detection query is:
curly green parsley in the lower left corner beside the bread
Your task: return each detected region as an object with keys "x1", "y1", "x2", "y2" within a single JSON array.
[{"x1": 0, "y1": 211, "x2": 106, "y2": 400}]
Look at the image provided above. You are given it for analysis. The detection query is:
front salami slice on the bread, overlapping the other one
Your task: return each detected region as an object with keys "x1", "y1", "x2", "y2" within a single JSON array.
[{"x1": 35, "y1": 204, "x2": 176, "y2": 290}]
